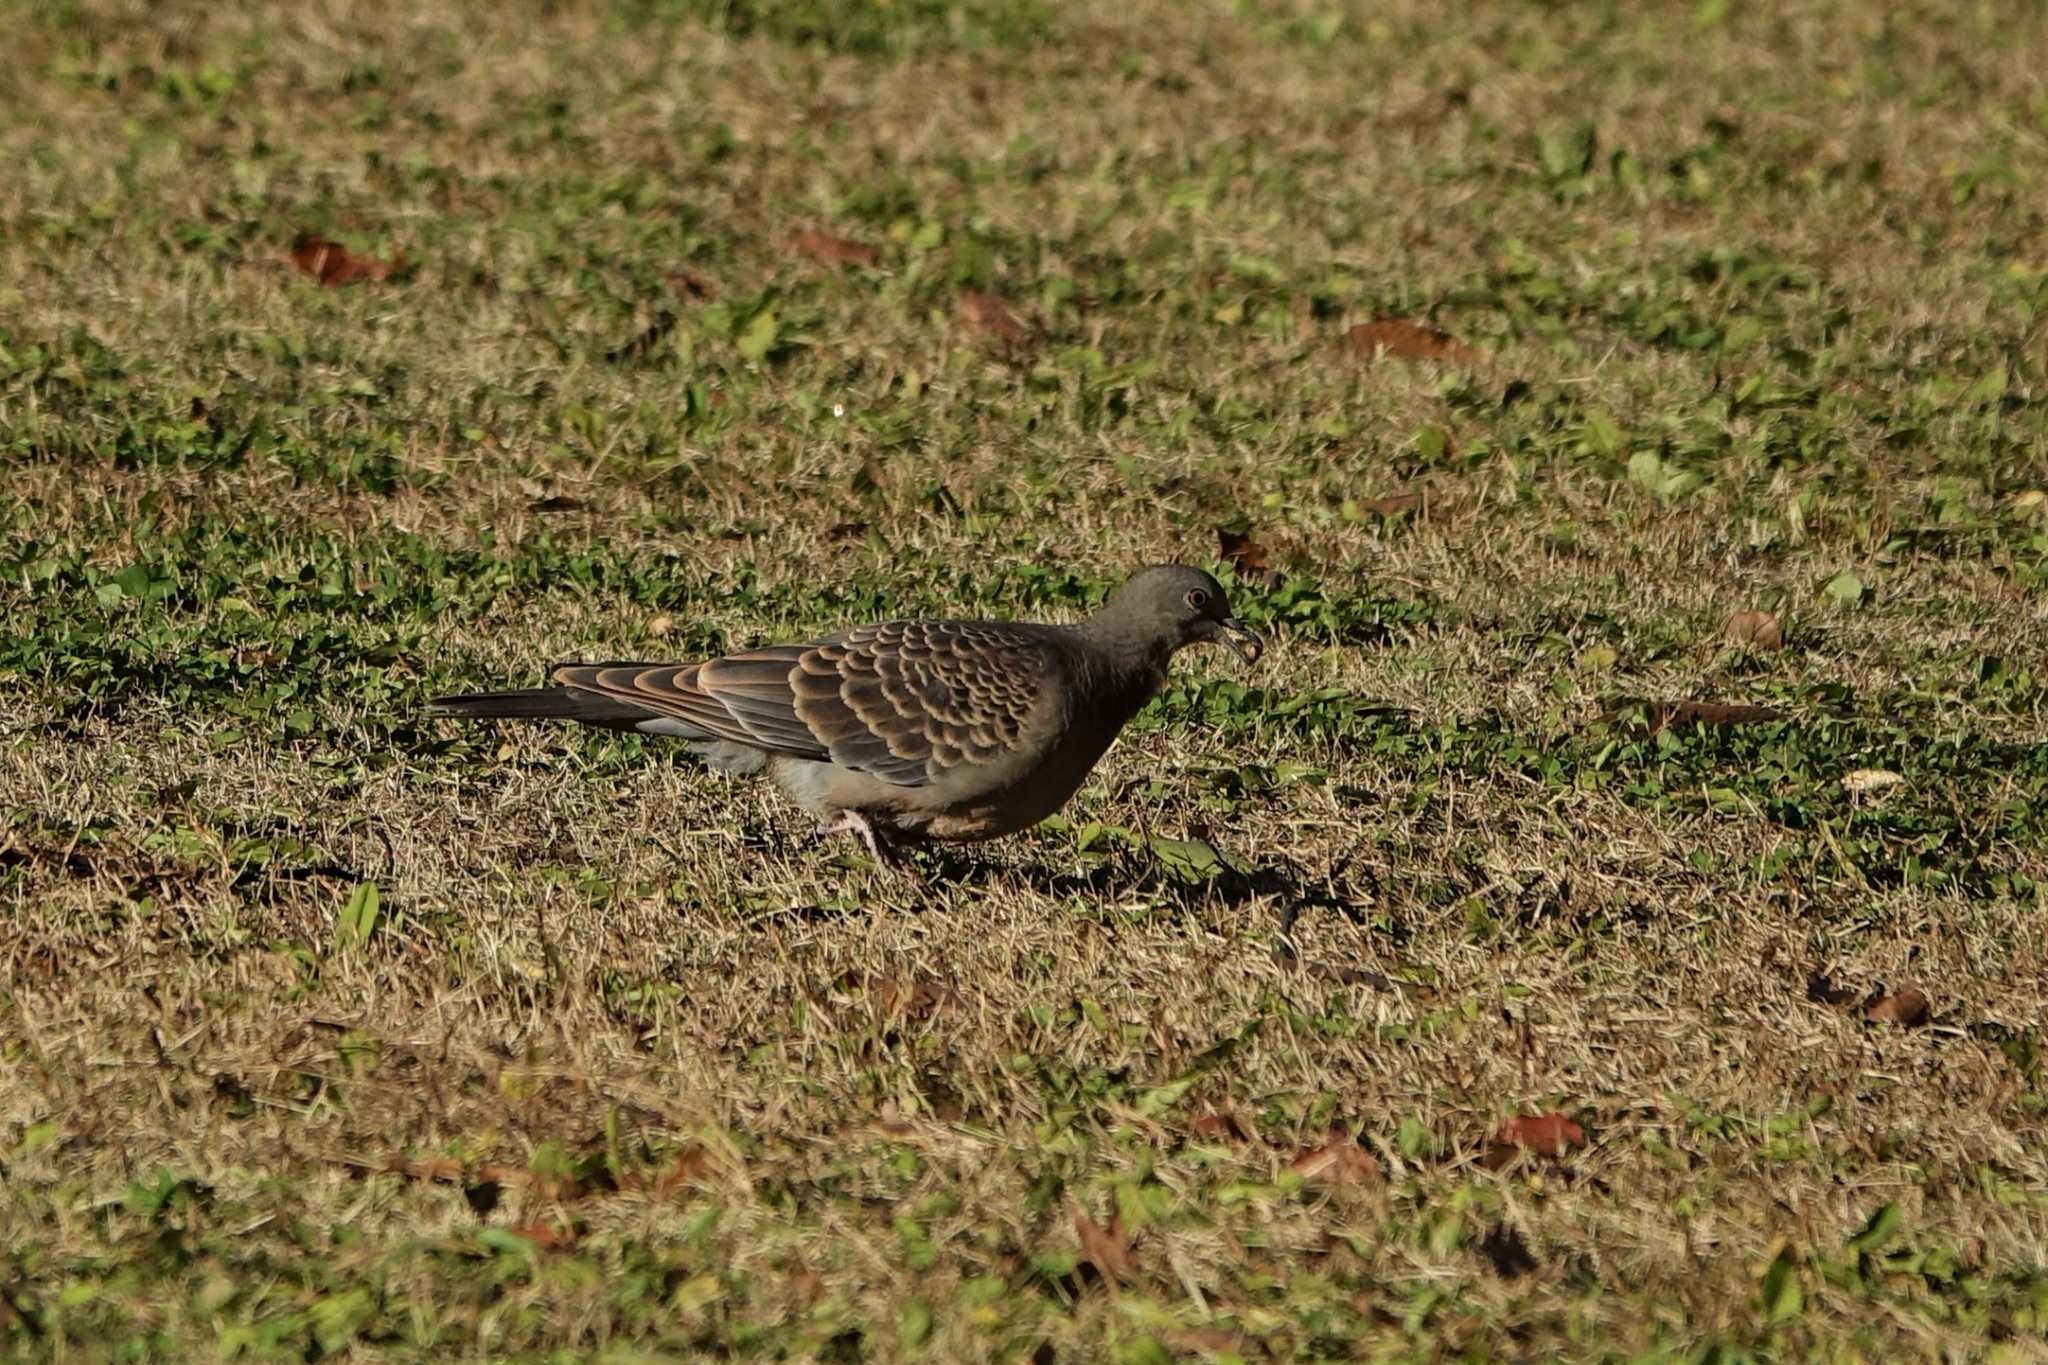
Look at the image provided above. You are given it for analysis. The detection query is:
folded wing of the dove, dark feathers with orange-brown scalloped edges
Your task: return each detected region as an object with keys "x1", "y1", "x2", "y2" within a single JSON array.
[{"x1": 555, "y1": 620, "x2": 1055, "y2": 786}]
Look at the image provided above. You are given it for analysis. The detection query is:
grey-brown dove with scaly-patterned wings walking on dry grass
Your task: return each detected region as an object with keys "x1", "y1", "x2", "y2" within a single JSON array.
[{"x1": 430, "y1": 565, "x2": 1264, "y2": 864}]
